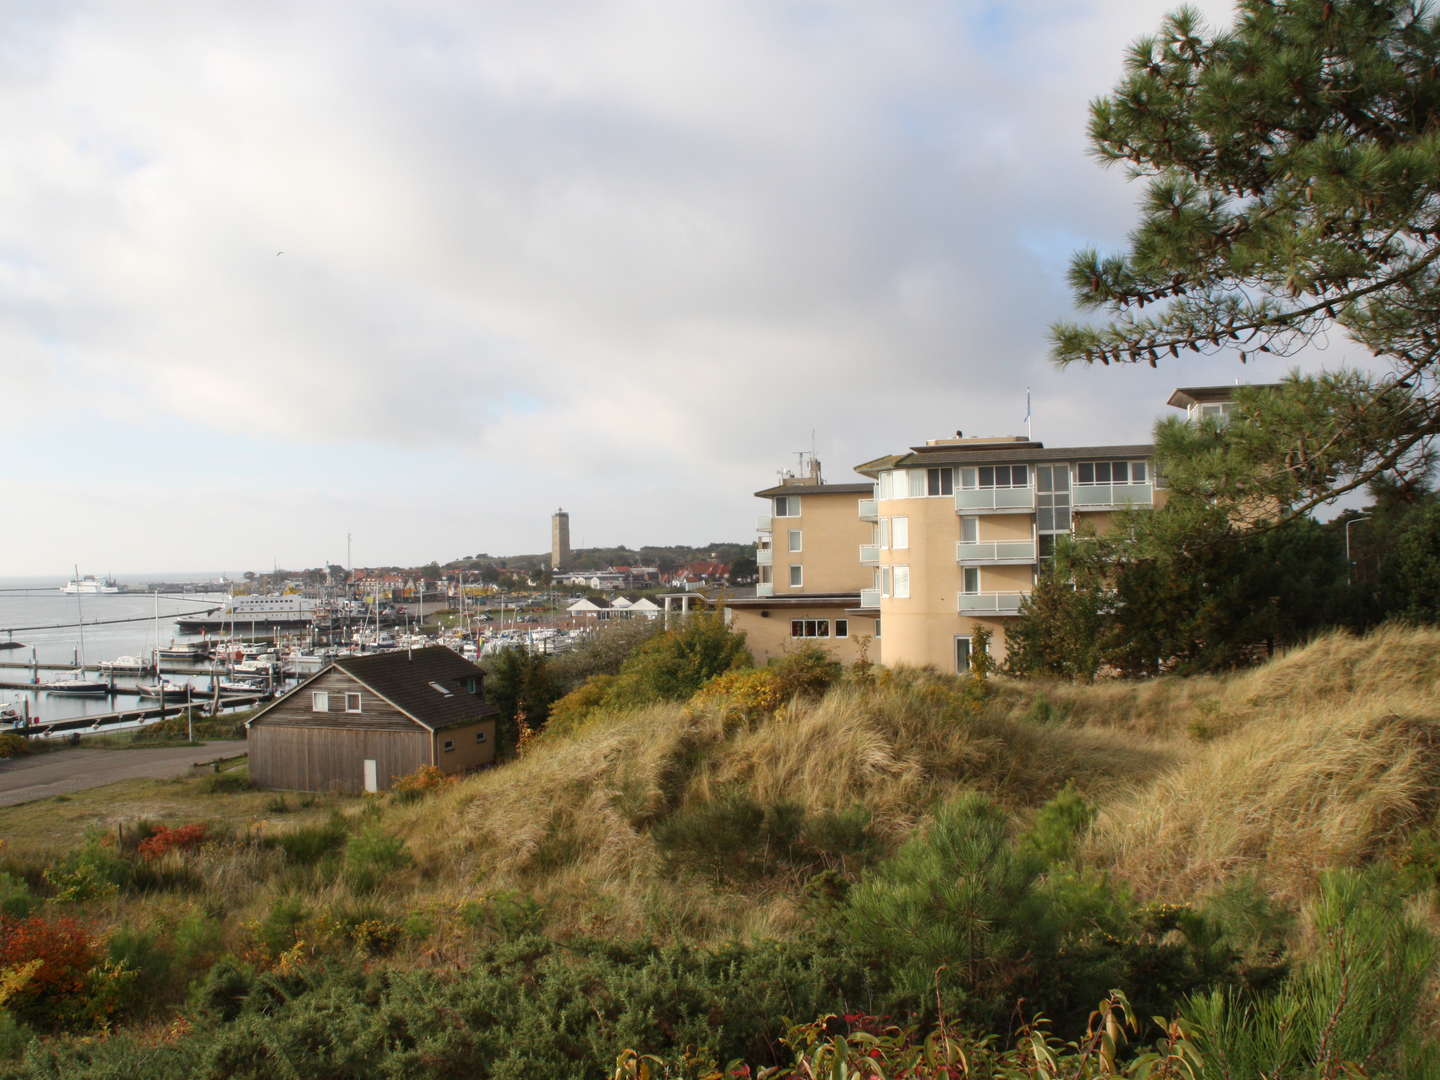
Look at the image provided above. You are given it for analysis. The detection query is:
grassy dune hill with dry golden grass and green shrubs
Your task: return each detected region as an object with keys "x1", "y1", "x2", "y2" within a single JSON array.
[{"x1": 0, "y1": 629, "x2": 1440, "y2": 1076}]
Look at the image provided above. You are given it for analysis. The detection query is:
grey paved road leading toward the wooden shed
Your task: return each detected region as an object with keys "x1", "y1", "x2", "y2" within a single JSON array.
[{"x1": 0, "y1": 739, "x2": 245, "y2": 806}]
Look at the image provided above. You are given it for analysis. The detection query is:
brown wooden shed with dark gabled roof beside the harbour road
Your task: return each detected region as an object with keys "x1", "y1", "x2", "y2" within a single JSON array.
[{"x1": 245, "y1": 645, "x2": 500, "y2": 793}]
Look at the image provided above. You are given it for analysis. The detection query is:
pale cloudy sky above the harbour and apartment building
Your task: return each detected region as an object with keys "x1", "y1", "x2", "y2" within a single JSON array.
[{"x1": 0, "y1": 0, "x2": 1359, "y2": 575}]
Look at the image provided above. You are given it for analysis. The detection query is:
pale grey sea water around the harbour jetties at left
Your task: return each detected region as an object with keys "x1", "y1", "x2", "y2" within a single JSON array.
[{"x1": 0, "y1": 573, "x2": 239, "y2": 720}]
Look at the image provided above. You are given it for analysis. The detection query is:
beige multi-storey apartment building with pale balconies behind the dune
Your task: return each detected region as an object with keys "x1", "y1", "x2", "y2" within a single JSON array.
[{"x1": 727, "y1": 386, "x2": 1234, "y2": 671}]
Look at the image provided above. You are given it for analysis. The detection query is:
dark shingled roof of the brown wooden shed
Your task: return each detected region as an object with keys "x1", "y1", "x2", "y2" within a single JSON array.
[{"x1": 336, "y1": 645, "x2": 500, "y2": 730}]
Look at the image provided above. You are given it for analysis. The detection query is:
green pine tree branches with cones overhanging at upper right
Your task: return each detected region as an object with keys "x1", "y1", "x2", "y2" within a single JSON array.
[{"x1": 1053, "y1": 0, "x2": 1440, "y2": 514}]
